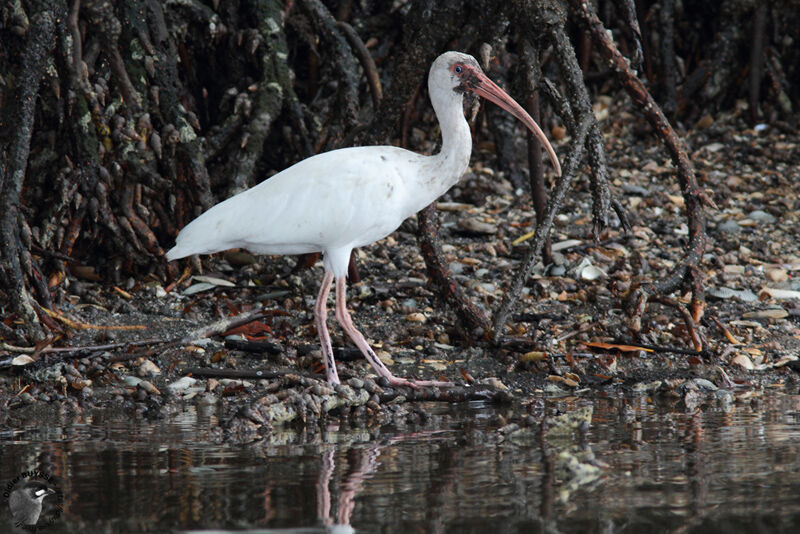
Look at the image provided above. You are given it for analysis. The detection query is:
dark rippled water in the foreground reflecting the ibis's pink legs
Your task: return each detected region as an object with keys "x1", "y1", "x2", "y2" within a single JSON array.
[{"x1": 0, "y1": 392, "x2": 800, "y2": 534}]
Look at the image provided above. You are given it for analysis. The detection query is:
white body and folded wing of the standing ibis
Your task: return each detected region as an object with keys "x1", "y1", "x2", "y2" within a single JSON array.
[{"x1": 167, "y1": 147, "x2": 422, "y2": 259}]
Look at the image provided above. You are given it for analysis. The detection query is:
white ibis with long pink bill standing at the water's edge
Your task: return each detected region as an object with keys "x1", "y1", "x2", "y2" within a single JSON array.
[{"x1": 167, "y1": 52, "x2": 561, "y2": 387}]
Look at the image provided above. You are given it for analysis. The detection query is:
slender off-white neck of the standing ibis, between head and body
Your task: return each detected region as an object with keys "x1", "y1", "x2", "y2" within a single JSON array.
[{"x1": 419, "y1": 93, "x2": 472, "y2": 201}]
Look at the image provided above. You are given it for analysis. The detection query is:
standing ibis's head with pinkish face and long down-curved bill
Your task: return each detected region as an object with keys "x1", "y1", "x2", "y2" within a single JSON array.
[{"x1": 428, "y1": 52, "x2": 561, "y2": 176}]
